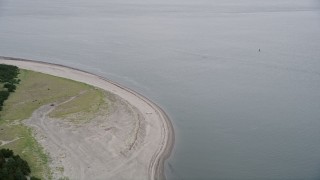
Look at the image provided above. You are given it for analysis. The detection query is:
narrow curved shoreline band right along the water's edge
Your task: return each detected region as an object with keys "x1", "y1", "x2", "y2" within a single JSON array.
[{"x1": 0, "y1": 56, "x2": 175, "y2": 179}]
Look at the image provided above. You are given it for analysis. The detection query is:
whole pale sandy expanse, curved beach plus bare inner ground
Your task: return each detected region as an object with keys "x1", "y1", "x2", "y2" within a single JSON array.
[{"x1": 0, "y1": 57, "x2": 174, "y2": 179}]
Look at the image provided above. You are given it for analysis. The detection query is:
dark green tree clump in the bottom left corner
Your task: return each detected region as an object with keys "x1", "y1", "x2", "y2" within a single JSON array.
[{"x1": 0, "y1": 149, "x2": 38, "y2": 180}]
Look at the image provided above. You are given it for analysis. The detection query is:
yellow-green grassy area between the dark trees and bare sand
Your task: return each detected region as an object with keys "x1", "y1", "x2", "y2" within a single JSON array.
[{"x1": 0, "y1": 70, "x2": 107, "y2": 178}]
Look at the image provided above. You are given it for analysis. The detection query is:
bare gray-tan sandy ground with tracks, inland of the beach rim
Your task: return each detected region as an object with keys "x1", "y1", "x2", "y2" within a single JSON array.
[{"x1": 24, "y1": 92, "x2": 146, "y2": 179}]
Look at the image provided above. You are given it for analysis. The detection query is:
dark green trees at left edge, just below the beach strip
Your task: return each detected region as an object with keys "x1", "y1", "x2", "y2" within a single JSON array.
[{"x1": 0, "y1": 64, "x2": 20, "y2": 111}]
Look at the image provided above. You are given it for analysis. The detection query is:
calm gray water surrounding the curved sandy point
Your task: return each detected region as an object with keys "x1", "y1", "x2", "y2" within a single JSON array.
[{"x1": 0, "y1": 0, "x2": 320, "y2": 180}]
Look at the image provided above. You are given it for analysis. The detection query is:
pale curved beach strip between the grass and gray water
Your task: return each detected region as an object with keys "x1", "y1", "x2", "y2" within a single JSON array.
[{"x1": 0, "y1": 56, "x2": 174, "y2": 179}]
